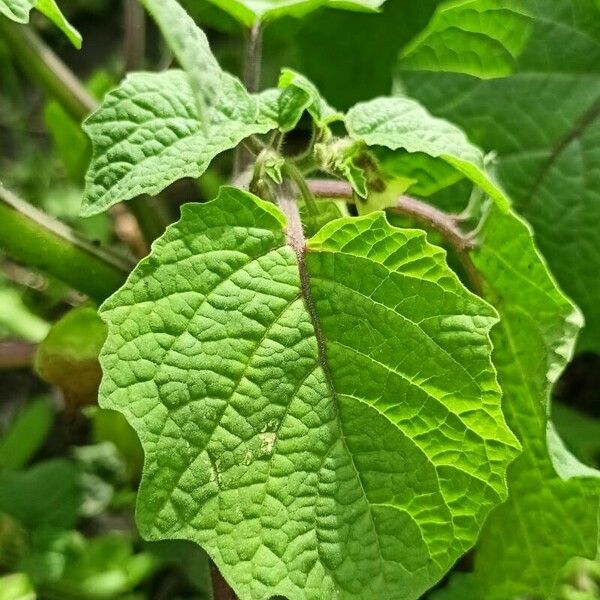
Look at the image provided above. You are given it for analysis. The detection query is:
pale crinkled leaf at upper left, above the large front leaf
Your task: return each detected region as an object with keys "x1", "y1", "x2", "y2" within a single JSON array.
[{"x1": 81, "y1": 70, "x2": 272, "y2": 216}]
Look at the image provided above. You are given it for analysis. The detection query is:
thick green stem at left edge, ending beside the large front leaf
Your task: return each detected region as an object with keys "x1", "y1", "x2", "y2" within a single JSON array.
[{"x1": 0, "y1": 186, "x2": 133, "y2": 303}]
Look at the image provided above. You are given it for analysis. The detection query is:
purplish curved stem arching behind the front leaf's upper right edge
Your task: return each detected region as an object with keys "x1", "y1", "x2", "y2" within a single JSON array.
[{"x1": 307, "y1": 179, "x2": 481, "y2": 295}]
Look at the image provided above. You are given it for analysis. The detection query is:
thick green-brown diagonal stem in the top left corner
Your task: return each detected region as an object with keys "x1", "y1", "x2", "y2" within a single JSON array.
[{"x1": 0, "y1": 18, "x2": 97, "y2": 122}]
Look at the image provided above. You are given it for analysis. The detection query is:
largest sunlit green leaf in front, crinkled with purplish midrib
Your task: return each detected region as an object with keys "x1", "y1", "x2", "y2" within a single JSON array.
[{"x1": 100, "y1": 188, "x2": 518, "y2": 600}]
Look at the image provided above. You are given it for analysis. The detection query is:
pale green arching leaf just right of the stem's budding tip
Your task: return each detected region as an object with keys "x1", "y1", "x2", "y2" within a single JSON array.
[{"x1": 346, "y1": 98, "x2": 510, "y2": 210}]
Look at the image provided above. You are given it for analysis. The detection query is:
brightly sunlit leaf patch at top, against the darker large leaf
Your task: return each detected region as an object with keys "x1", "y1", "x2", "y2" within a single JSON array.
[{"x1": 400, "y1": 0, "x2": 533, "y2": 78}]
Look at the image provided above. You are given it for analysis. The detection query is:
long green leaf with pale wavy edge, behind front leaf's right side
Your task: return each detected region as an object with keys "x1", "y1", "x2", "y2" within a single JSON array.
[{"x1": 436, "y1": 210, "x2": 600, "y2": 600}]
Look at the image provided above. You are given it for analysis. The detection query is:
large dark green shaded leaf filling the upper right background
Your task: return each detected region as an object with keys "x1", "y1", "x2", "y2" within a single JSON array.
[{"x1": 401, "y1": 0, "x2": 600, "y2": 351}]
